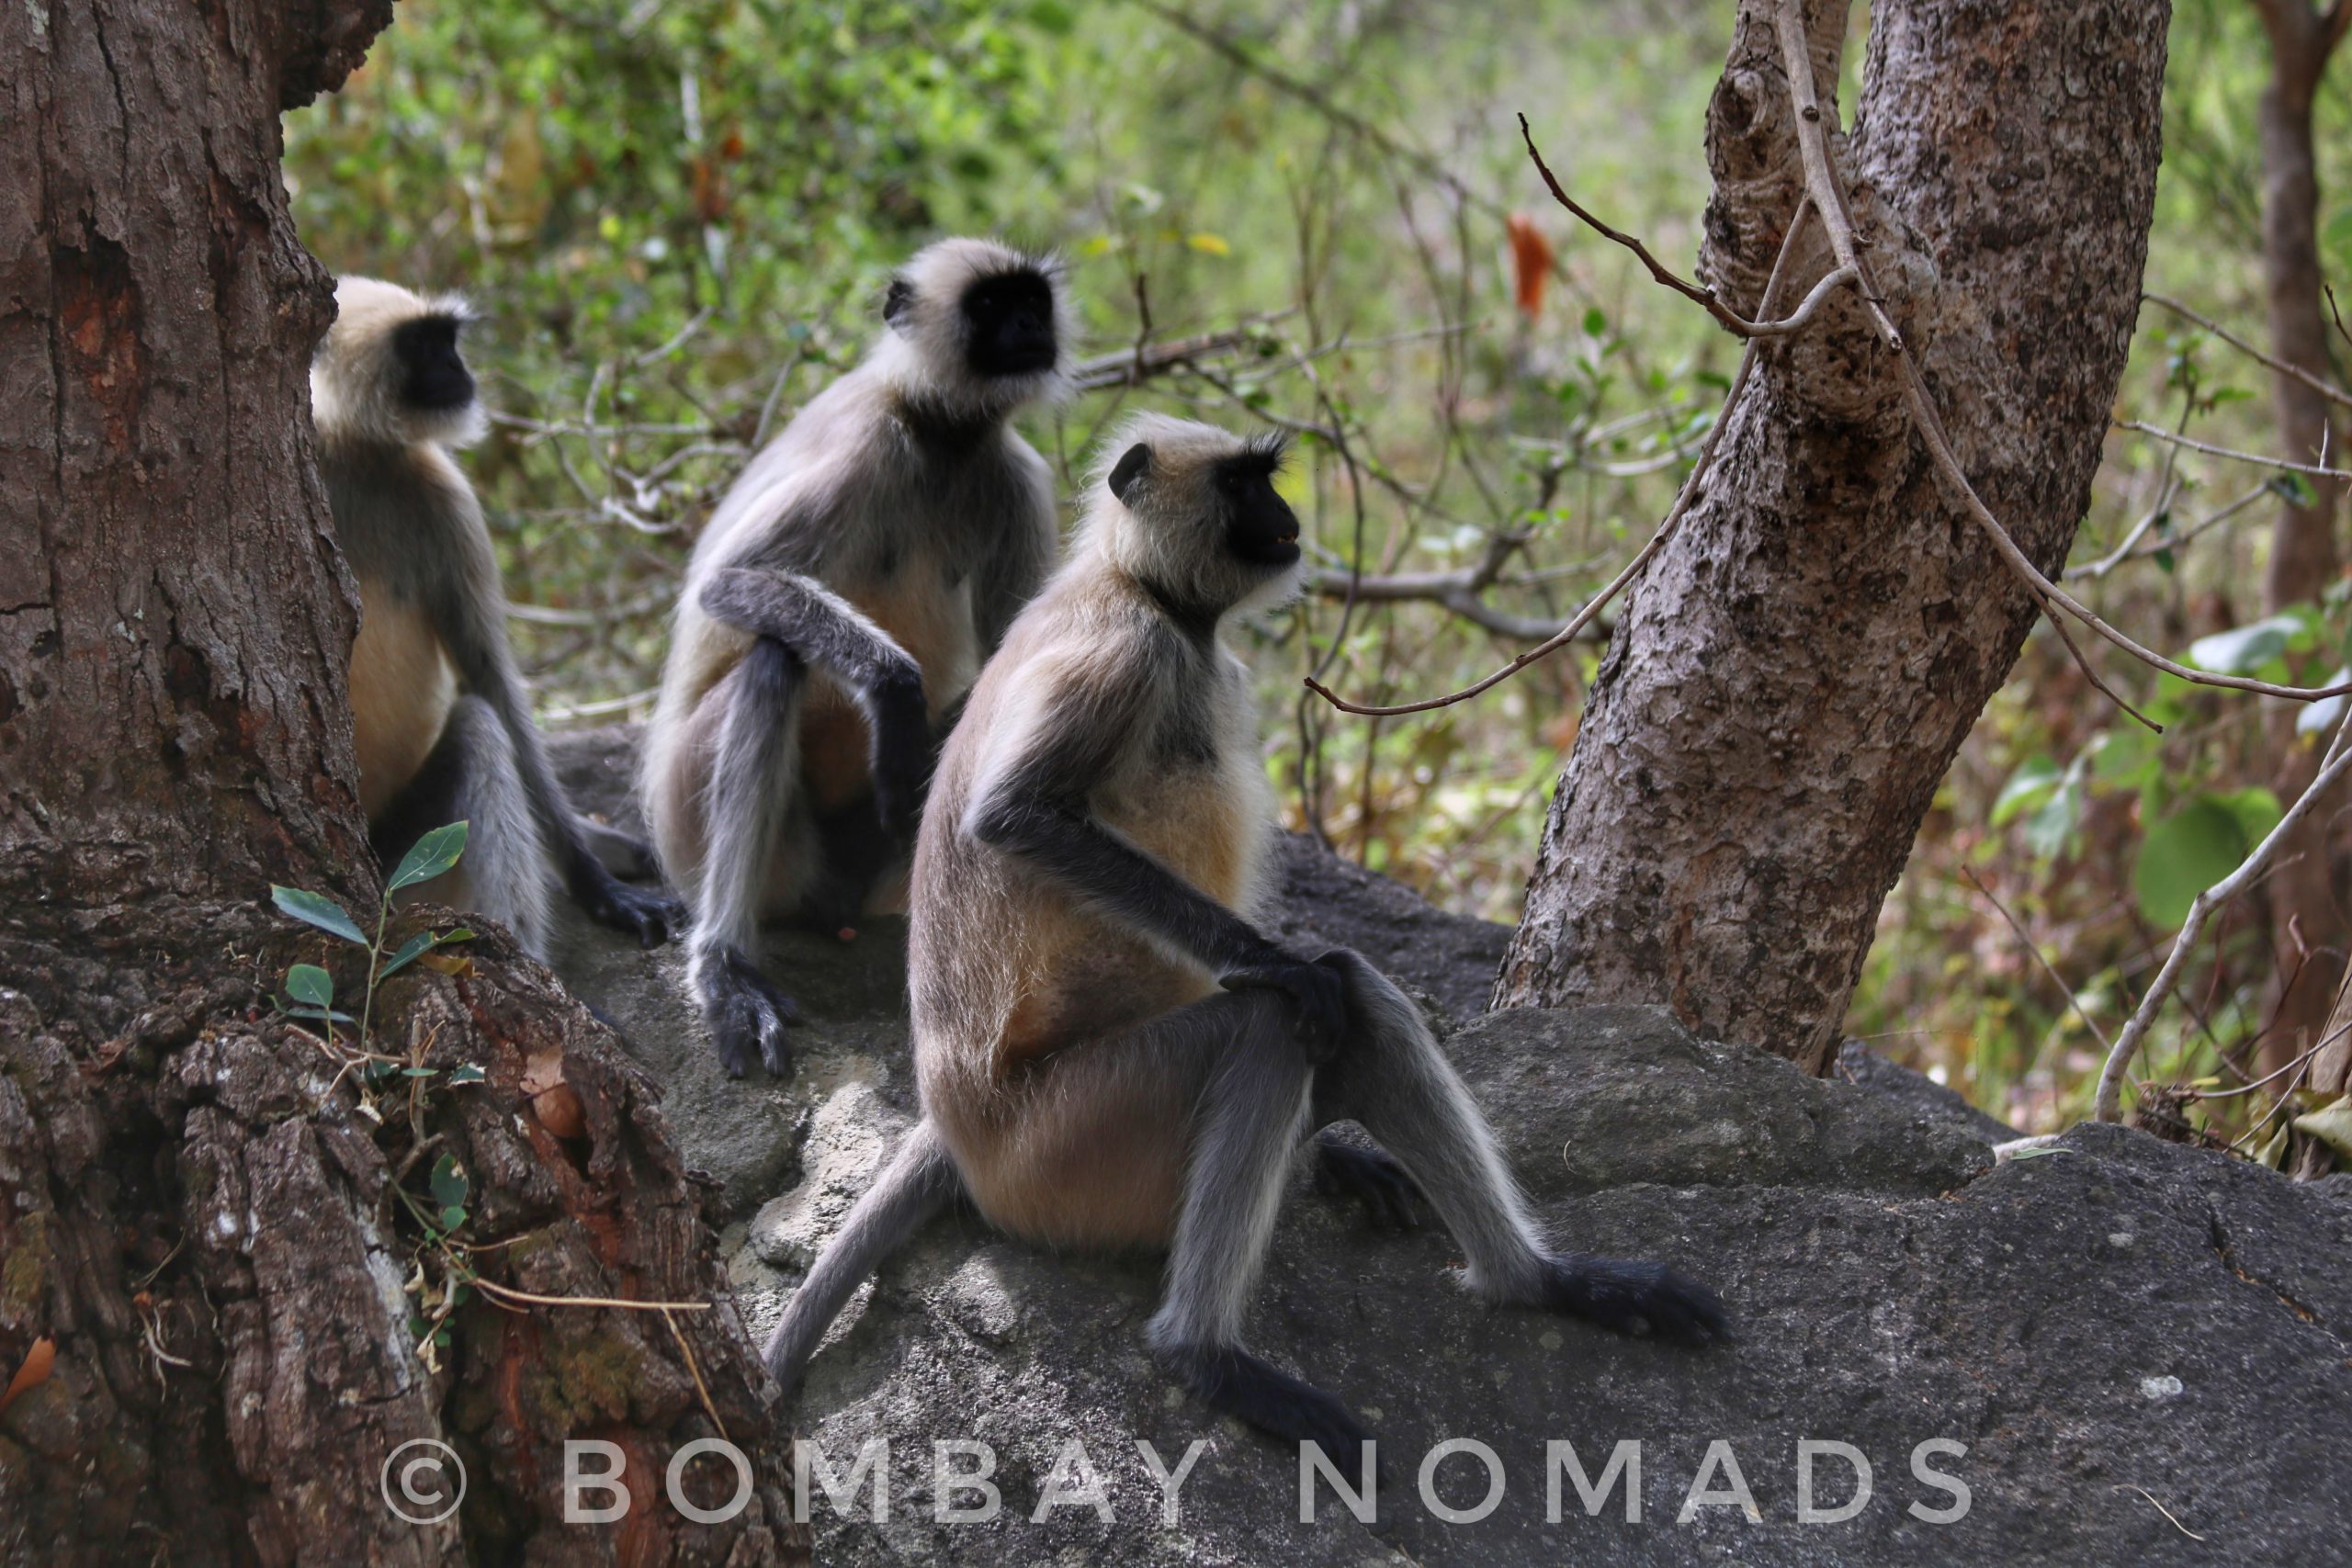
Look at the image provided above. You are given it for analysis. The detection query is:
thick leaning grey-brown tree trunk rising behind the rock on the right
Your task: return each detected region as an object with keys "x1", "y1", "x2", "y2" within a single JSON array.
[{"x1": 1494, "y1": 0, "x2": 2168, "y2": 1072}]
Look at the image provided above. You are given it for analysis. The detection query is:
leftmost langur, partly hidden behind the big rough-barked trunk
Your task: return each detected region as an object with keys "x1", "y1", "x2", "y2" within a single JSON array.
[{"x1": 311, "y1": 277, "x2": 684, "y2": 959}]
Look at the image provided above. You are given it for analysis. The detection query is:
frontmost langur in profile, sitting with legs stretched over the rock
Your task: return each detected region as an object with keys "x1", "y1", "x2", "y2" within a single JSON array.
[{"x1": 767, "y1": 416, "x2": 1729, "y2": 1460}]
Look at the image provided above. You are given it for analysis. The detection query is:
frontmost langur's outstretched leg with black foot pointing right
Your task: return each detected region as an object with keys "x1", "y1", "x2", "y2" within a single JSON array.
[{"x1": 1315, "y1": 947, "x2": 1731, "y2": 1345}]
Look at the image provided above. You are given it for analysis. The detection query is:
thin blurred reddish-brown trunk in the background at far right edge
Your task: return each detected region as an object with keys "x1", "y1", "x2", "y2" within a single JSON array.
[{"x1": 2256, "y1": 0, "x2": 2352, "y2": 1090}]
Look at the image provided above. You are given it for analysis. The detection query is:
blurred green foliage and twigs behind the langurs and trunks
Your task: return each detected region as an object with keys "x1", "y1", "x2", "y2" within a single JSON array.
[{"x1": 287, "y1": 0, "x2": 2352, "y2": 1140}]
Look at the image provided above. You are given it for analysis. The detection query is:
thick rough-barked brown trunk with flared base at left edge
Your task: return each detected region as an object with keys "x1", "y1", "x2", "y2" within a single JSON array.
[{"x1": 0, "y1": 0, "x2": 795, "y2": 1563}]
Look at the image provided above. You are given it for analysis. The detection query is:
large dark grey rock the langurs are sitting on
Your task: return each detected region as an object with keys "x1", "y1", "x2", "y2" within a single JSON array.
[{"x1": 545, "y1": 736, "x2": 2352, "y2": 1565}]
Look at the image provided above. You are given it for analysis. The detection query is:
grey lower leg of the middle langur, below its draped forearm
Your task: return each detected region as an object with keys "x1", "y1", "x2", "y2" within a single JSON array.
[{"x1": 687, "y1": 637, "x2": 807, "y2": 1077}]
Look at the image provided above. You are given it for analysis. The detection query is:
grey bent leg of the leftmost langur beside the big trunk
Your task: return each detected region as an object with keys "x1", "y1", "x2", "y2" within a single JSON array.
[{"x1": 369, "y1": 696, "x2": 555, "y2": 959}]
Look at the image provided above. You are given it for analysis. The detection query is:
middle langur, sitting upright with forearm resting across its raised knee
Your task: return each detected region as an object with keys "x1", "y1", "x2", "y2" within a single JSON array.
[{"x1": 642, "y1": 240, "x2": 1068, "y2": 1077}]
